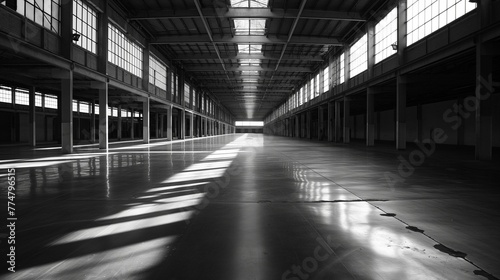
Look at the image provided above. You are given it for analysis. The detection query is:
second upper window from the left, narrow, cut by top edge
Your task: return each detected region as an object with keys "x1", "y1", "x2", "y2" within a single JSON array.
[{"x1": 73, "y1": 0, "x2": 97, "y2": 53}]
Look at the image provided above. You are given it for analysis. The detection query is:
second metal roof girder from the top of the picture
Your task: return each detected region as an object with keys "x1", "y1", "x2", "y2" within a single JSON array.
[{"x1": 151, "y1": 35, "x2": 344, "y2": 46}]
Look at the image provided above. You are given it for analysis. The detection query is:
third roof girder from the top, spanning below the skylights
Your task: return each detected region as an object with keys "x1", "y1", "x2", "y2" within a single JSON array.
[{"x1": 172, "y1": 53, "x2": 325, "y2": 62}]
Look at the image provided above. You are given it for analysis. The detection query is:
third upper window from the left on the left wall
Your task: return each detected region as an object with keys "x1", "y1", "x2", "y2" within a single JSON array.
[{"x1": 108, "y1": 24, "x2": 142, "y2": 78}]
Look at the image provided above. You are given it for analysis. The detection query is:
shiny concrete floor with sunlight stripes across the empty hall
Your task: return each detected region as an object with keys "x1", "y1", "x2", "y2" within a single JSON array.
[{"x1": 0, "y1": 134, "x2": 500, "y2": 280}]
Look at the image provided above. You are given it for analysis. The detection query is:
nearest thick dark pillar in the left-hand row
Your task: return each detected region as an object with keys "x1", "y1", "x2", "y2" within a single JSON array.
[{"x1": 61, "y1": 70, "x2": 73, "y2": 154}]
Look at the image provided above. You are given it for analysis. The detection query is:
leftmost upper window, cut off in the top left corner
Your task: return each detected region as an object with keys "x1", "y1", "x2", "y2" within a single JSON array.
[{"x1": 2, "y1": 0, "x2": 61, "y2": 34}]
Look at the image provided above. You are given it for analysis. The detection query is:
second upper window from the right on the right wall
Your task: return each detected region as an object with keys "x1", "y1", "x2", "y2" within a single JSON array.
[{"x1": 375, "y1": 8, "x2": 398, "y2": 63}]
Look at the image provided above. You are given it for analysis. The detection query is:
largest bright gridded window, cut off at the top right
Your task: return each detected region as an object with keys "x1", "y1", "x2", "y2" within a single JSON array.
[{"x1": 406, "y1": 0, "x2": 476, "y2": 46}]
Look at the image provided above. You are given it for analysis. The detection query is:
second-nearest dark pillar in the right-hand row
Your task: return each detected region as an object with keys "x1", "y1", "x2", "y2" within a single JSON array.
[{"x1": 396, "y1": 74, "x2": 407, "y2": 150}]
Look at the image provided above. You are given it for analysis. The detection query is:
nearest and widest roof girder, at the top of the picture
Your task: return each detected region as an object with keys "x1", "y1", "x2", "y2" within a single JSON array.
[{"x1": 130, "y1": 8, "x2": 366, "y2": 21}]
